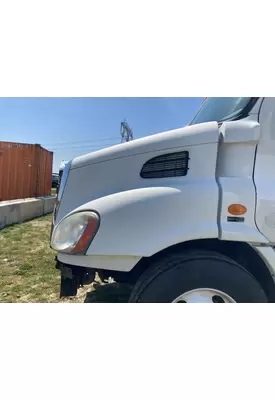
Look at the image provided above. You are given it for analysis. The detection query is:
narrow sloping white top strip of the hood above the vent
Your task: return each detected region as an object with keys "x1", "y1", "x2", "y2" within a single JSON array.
[{"x1": 71, "y1": 122, "x2": 219, "y2": 169}]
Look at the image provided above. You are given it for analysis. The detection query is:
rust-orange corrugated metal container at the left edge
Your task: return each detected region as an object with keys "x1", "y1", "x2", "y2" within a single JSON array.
[{"x1": 0, "y1": 142, "x2": 53, "y2": 201}]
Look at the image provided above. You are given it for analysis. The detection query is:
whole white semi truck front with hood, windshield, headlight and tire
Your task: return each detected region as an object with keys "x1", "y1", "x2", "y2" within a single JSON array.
[{"x1": 51, "y1": 97, "x2": 275, "y2": 303}]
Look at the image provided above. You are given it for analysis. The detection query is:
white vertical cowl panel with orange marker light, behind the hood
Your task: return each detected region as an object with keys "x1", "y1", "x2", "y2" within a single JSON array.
[{"x1": 216, "y1": 118, "x2": 268, "y2": 243}]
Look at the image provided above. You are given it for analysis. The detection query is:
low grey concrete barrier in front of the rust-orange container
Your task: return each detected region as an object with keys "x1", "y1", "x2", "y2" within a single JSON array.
[{"x1": 0, "y1": 196, "x2": 56, "y2": 229}]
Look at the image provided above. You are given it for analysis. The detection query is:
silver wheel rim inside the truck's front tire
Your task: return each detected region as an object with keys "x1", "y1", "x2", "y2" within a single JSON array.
[{"x1": 172, "y1": 288, "x2": 236, "y2": 303}]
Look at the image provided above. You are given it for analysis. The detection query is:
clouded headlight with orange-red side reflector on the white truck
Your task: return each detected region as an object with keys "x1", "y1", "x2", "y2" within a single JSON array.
[{"x1": 51, "y1": 211, "x2": 99, "y2": 254}]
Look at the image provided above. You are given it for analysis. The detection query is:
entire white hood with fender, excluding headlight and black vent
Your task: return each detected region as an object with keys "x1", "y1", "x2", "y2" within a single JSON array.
[{"x1": 57, "y1": 123, "x2": 219, "y2": 257}]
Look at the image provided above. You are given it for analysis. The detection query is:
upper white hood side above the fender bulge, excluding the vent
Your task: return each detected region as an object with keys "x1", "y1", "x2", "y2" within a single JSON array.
[{"x1": 56, "y1": 122, "x2": 219, "y2": 222}]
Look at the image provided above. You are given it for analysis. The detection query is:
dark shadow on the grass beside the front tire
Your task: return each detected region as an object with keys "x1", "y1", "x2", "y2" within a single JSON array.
[{"x1": 84, "y1": 283, "x2": 132, "y2": 303}]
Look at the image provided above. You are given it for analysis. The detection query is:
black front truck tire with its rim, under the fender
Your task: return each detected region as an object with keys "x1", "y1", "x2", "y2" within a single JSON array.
[{"x1": 129, "y1": 250, "x2": 268, "y2": 303}]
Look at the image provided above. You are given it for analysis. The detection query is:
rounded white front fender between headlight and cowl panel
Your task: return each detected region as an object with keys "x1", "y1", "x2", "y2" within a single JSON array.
[{"x1": 71, "y1": 184, "x2": 218, "y2": 257}]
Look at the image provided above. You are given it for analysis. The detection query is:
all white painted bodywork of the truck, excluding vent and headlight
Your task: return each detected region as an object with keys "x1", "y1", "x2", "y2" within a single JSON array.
[{"x1": 51, "y1": 98, "x2": 275, "y2": 282}]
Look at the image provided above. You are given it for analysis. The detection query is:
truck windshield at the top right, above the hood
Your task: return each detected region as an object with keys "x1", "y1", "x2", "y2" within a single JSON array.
[{"x1": 190, "y1": 97, "x2": 257, "y2": 125}]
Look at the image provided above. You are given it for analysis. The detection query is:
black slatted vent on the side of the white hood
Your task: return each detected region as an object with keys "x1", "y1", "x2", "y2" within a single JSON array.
[{"x1": 140, "y1": 151, "x2": 189, "y2": 179}]
